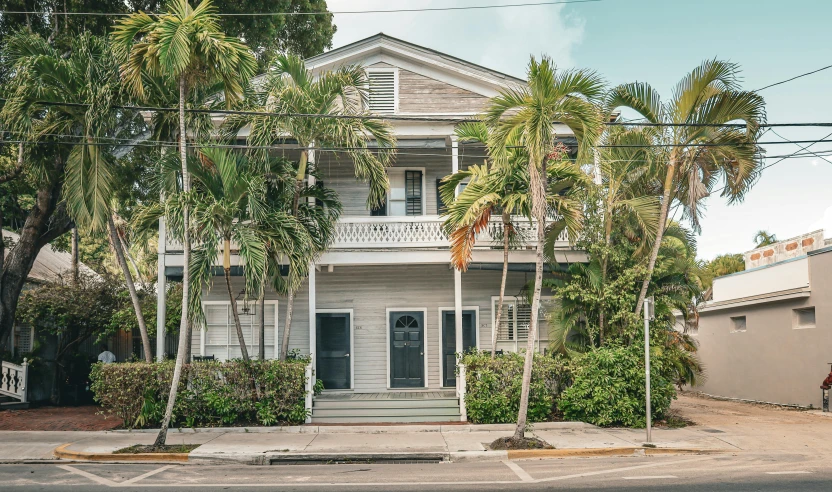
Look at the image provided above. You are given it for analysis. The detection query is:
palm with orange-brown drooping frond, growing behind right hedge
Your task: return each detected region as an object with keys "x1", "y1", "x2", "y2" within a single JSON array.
[{"x1": 440, "y1": 122, "x2": 532, "y2": 359}]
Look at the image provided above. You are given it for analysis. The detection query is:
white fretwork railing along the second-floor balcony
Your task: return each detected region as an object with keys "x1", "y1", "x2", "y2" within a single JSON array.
[{"x1": 165, "y1": 215, "x2": 568, "y2": 251}]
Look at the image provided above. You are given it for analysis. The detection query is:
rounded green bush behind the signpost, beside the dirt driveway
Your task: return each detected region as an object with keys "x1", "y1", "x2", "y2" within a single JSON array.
[{"x1": 558, "y1": 345, "x2": 676, "y2": 427}]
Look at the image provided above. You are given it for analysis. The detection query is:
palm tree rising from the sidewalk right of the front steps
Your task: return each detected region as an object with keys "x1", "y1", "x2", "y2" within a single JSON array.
[{"x1": 485, "y1": 57, "x2": 604, "y2": 440}]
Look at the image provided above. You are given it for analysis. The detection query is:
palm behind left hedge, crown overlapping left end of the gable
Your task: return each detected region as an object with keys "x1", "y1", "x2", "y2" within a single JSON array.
[{"x1": 227, "y1": 55, "x2": 395, "y2": 359}]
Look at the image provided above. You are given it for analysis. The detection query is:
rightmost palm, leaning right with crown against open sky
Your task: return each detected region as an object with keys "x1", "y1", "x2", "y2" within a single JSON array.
[{"x1": 606, "y1": 60, "x2": 765, "y2": 314}]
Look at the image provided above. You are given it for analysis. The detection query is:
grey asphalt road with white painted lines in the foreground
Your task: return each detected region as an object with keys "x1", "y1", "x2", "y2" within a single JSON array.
[{"x1": 0, "y1": 454, "x2": 832, "y2": 492}]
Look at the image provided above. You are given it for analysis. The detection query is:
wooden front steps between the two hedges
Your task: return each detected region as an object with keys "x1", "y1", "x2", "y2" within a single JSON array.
[{"x1": 312, "y1": 391, "x2": 460, "y2": 424}]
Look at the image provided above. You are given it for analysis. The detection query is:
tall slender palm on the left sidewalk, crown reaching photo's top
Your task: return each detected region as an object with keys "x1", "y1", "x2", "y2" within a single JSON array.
[{"x1": 112, "y1": 0, "x2": 257, "y2": 447}]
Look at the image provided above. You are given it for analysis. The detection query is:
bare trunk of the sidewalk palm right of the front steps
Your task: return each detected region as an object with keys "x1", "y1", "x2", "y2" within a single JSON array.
[{"x1": 512, "y1": 159, "x2": 546, "y2": 440}]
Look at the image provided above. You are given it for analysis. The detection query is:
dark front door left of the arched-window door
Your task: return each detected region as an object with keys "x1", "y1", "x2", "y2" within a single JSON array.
[{"x1": 315, "y1": 313, "x2": 352, "y2": 389}]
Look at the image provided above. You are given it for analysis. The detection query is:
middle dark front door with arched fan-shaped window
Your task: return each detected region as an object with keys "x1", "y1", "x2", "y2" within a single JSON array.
[{"x1": 390, "y1": 311, "x2": 425, "y2": 388}]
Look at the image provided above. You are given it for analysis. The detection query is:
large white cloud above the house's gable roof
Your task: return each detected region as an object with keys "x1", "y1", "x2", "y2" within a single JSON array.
[{"x1": 328, "y1": 0, "x2": 585, "y2": 78}]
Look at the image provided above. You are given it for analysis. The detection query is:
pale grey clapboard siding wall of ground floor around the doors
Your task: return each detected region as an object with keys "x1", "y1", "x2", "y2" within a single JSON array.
[{"x1": 193, "y1": 265, "x2": 545, "y2": 392}]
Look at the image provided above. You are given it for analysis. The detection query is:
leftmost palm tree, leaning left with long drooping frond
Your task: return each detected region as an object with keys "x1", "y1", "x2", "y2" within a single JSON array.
[{"x1": 3, "y1": 33, "x2": 153, "y2": 362}]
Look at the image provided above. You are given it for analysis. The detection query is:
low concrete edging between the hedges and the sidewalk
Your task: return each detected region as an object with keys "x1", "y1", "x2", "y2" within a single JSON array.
[{"x1": 107, "y1": 422, "x2": 596, "y2": 434}]
